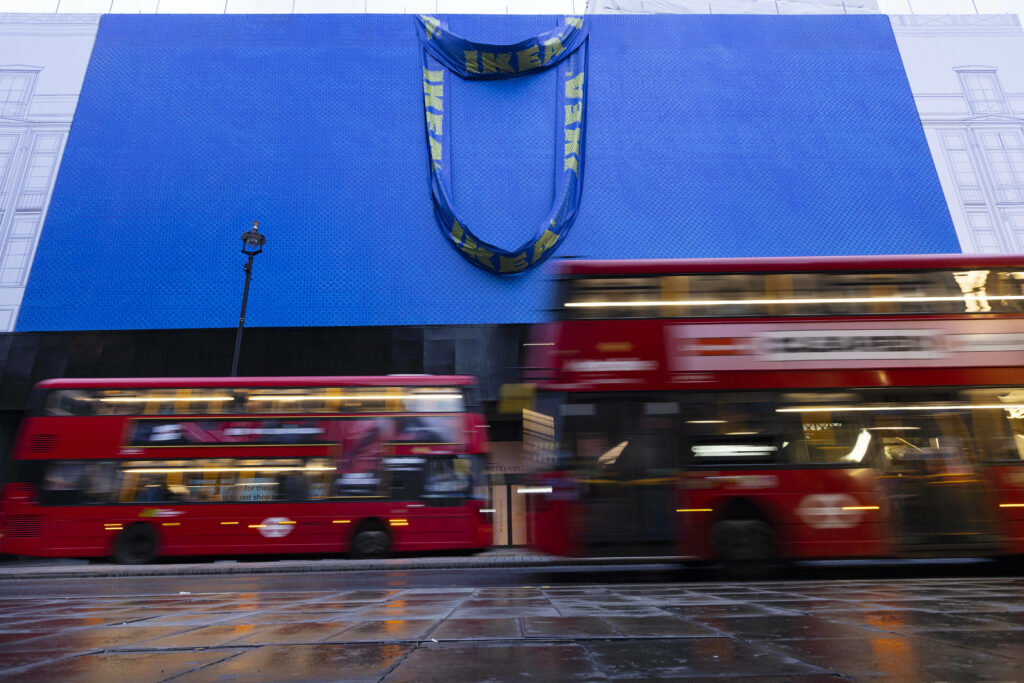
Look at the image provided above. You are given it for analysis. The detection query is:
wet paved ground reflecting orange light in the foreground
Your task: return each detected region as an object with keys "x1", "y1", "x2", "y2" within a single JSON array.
[{"x1": 0, "y1": 569, "x2": 1024, "y2": 683}]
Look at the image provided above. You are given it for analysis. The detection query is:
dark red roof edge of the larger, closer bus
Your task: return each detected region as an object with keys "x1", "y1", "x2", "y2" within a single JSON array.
[{"x1": 557, "y1": 254, "x2": 1024, "y2": 276}]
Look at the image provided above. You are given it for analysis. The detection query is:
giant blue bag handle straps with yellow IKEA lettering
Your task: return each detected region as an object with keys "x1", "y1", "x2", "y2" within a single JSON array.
[{"x1": 418, "y1": 16, "x2": 588, "y2": 275}]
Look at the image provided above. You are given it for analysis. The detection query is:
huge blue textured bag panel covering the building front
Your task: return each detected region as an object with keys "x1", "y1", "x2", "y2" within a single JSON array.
[{"x1": 17, "y1": 14, "x2": 959, "y2": 331}]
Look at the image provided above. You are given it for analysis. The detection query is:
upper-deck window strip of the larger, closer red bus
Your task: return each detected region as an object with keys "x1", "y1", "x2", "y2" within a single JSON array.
[{"x1": 561, "y1": 268, "x2": 1024, "y2": 319}]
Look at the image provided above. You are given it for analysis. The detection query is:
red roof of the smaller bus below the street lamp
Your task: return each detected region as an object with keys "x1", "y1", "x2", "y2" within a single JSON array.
[{"x1": 36, "y1": 375, "x2": 476, "y2": 389}]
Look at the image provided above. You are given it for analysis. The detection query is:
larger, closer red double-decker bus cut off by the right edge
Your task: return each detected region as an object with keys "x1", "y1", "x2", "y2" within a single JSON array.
[{"x1": 524, "y1": 255, "x2": 1024, "y2": 564}]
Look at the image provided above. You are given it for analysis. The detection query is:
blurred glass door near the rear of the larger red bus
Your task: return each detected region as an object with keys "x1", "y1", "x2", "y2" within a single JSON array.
[{"x1": 867, "y1": 412, "x2": 997, "y2": 554}]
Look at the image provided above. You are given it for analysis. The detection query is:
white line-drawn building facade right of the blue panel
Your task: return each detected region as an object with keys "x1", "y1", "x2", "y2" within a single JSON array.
[{"x1": 891, "y1": 14, "x2": 1024, "y2": 253}]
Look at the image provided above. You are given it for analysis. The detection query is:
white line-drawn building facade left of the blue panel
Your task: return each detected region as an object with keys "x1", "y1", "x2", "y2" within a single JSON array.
[{"x1": 0, "y1": 13, "x2": 99, "y2": 332}]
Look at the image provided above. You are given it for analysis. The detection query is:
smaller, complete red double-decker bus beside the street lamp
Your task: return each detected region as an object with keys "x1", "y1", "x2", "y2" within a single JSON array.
[{"x1": 0, "y1": 376, "x2": 492, "y2": 563}]
